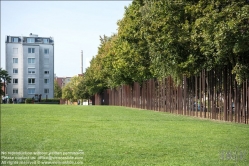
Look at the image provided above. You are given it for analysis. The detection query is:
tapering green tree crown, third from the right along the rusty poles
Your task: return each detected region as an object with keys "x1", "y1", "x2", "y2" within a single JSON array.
[{"x1": 113, "y1": 0, "x2": 152, "y2": 84}]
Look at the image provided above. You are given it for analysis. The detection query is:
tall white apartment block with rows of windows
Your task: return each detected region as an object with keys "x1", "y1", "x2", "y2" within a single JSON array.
[{"x1": 5, "y1": 33, "x2": 54, "y2": 99}]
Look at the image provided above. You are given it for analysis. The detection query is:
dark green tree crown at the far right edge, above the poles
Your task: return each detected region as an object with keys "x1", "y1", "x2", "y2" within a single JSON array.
[{"x1": 189, "y1": 0, "x2": 249, "y2": 84}]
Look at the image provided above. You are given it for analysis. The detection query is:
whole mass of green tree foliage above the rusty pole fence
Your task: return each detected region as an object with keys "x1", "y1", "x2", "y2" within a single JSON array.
[{"x1": 80, "y1": 0, "x2": 249, "y2": 95}]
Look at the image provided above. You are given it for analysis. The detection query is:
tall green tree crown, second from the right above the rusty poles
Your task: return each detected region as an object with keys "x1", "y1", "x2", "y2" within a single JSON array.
[{"x1": 140, "y1": 0, "x2": 192, "y2": 80}]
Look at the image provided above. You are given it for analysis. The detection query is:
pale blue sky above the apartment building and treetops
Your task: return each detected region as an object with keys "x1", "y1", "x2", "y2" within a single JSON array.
[{"x1": 1, "y1": 1, "x2": 132, "y2": 77}]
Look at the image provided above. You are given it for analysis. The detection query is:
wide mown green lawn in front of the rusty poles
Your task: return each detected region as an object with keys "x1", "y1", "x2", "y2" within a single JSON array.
[{"x1": 1, "y1": 104, "x2": 249, "y2": 166}]
